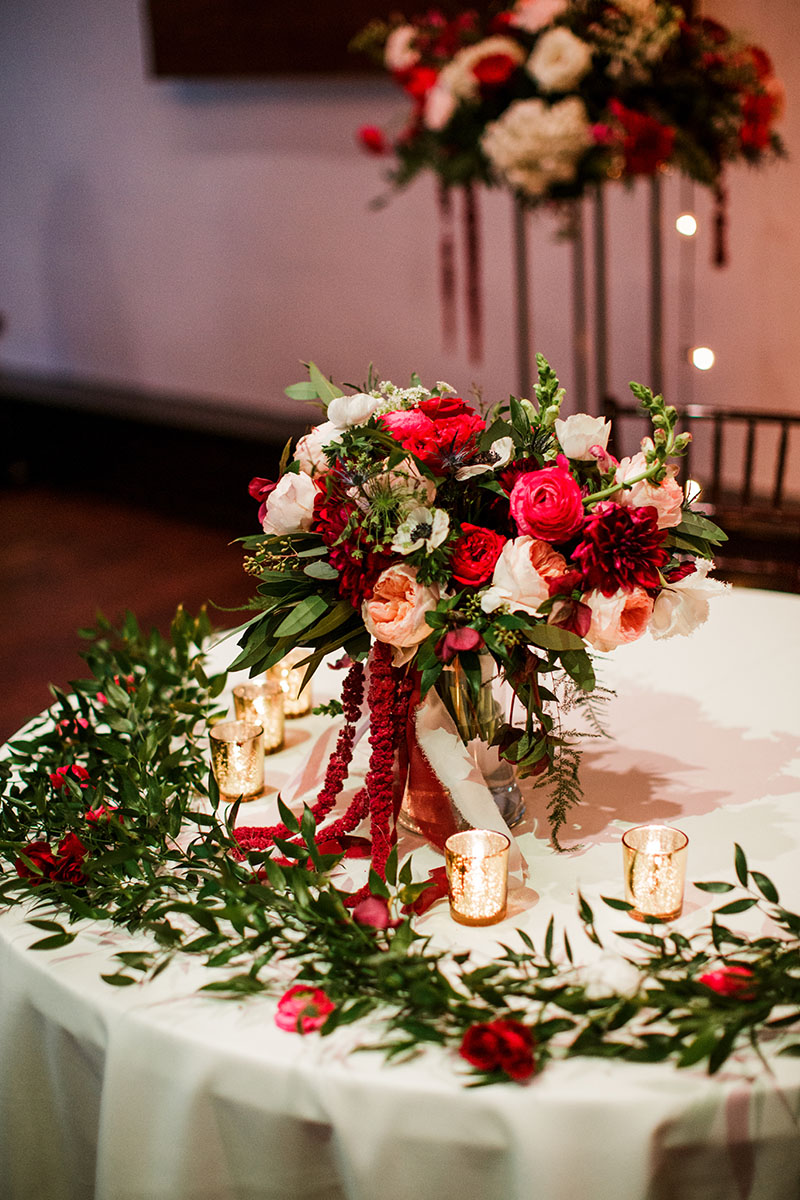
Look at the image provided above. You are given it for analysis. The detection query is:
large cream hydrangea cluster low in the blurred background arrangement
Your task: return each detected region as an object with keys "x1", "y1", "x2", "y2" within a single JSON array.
[{"x1": 481, "y1": 96, "x2": 591, "y2": 197}]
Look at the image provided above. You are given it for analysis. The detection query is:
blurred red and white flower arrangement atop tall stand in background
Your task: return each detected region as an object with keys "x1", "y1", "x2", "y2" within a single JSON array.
[{"x1": 354, "y1": 0, "x2": 783, "y2": 204}]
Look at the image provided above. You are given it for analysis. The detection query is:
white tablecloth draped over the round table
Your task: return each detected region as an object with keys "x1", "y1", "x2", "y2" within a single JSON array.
[{"x1": 0, "y1": 590, "x2": 800, "y2": 1200}]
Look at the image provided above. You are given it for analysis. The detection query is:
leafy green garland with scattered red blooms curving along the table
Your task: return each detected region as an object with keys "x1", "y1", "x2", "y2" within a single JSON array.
[{"x1": 0, "y1": 610, "x2": 800, "y2": 1084}]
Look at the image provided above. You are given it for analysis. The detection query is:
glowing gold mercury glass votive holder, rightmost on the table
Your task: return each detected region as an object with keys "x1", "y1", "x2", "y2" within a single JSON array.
[{"x1": 622, "y1": 824, "x2": 688, "y2": 922}]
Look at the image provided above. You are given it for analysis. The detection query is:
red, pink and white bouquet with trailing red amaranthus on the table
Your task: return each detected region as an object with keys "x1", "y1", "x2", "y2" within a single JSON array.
[{"x1": 233, "y1": 356, "x2": 724, "y2": 892}]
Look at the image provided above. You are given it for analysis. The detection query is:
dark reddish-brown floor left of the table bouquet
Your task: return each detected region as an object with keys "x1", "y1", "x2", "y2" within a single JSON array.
[{"x1": 0, "y1": 487, "x2": 257, "y2": 742}]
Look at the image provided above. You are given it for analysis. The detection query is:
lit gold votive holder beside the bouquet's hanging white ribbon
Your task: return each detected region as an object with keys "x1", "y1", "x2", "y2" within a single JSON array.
[{"x1": 445, "y1": 829, "x2": 511, "y2": 925}]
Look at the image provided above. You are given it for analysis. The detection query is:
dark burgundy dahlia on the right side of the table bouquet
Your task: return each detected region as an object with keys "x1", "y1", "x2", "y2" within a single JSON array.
[{"x1": 572, "y1": 500, "x2": 669, "y2": 596}]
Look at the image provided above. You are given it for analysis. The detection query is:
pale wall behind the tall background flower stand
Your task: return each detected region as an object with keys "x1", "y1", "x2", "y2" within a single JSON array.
[{"x1": 0, "y1": 0, "x2": 800, "y2": 432}]
